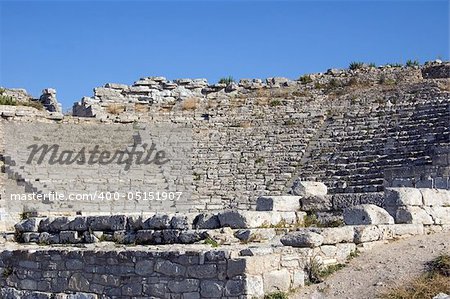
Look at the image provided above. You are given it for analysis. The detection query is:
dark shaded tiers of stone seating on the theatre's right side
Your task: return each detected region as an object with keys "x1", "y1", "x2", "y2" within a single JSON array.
[{"x1": 299, "y1": 85, "x2": 450, "y2": 193}]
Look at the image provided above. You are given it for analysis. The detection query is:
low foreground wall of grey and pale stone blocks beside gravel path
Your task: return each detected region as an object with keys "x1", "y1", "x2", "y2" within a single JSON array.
[{"x1": 0, "y1": 186, "x2": 450, "y2": 299}]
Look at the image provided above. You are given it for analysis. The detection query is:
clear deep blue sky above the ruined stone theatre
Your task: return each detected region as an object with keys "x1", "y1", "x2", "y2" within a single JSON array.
[{"x1": 0, "y1": 0, "x2": 449, "y2": 110}]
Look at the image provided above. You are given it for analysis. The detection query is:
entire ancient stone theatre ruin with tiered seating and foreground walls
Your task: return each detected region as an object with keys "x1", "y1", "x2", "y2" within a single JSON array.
[{"x1": 0, "y1": 61, "x2": 450, "y2": 299}]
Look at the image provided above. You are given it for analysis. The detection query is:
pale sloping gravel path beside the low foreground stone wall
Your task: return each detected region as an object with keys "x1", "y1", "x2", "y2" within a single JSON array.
[{"x1": 291, "y1": 232, "x2": 450, "y2": 299}]
